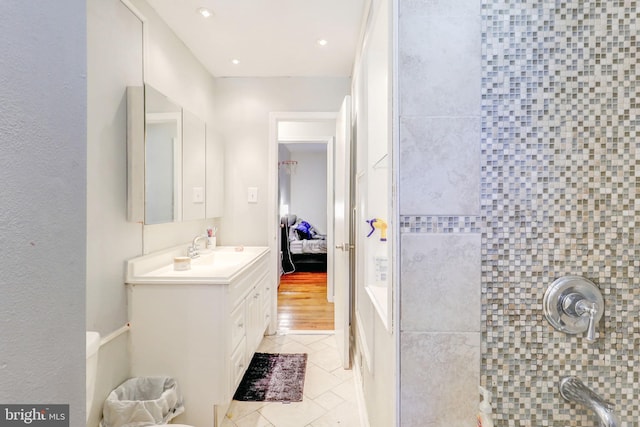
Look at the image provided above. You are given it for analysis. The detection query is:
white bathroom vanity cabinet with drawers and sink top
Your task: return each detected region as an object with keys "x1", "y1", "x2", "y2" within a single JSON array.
[{"x1": 126, "y1": 247, "x2": 275, "y2": 427}]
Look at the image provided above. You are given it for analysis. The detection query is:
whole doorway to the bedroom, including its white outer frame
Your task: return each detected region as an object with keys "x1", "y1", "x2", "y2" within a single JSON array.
[{"x1": 269, "y1": 112, "x2": 337, "y2": 333}]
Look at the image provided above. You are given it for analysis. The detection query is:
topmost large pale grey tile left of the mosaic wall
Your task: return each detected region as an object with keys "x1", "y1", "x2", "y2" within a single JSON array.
[{"x1": 398, "y1": 0, "x2": 481, "y2": 116}]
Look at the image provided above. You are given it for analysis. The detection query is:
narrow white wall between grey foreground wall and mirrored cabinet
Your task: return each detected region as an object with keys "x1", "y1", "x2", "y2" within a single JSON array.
[{"x1": 86, "y1": 0, "x2": 142, "y2": 426}]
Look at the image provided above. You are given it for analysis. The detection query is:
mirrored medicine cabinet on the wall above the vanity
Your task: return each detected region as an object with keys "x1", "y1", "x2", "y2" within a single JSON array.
[{"x1": 127, "y1": 84, "x2": 224, "y2": 225}]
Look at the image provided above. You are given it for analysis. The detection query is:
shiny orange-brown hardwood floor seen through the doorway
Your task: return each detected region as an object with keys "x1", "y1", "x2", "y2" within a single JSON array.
[{"x1": 278, "y1": 272, "x2": 333, "y2": 331}]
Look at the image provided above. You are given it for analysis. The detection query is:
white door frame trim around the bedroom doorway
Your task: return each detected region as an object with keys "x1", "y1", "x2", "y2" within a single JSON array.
[{"x1": 267, "y1": 111, "x2": 338, "y2": 334}]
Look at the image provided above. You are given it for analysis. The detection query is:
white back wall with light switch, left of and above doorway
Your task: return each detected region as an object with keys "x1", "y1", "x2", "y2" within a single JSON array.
[{"x1": 216, "y1": 77, "x2": 350, "y2": 245}]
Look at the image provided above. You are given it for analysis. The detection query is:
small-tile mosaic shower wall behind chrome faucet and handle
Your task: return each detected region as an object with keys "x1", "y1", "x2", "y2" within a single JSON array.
[{"x1": 480, "y1": 0, "x2": 640, "y2": 427}]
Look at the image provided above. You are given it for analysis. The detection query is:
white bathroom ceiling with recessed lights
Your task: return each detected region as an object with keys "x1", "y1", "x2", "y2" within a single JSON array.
[{"x1": 147, "y1": 0, "x2": 368, "y2": 77}]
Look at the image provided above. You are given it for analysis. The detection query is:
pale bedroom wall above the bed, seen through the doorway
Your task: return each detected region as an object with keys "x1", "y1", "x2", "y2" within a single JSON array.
[{"x1": 289, "y1": 149, "x2": 328, "y2": 234}]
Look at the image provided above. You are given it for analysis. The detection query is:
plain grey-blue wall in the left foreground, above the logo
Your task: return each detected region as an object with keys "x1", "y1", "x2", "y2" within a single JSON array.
[{"x1": 0, "y1": 0, "x2": 87, "y2": 426}]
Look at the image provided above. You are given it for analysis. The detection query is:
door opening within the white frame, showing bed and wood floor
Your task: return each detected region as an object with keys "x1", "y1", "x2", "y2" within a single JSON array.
[{"x1": 277, "y1": 139, "x2": 335, "y2": 333}]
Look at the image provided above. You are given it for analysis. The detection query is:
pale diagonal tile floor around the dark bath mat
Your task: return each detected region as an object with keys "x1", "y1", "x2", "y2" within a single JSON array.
[{"x1": 222, "y1": 333, "x2": 363, "y2": 427}]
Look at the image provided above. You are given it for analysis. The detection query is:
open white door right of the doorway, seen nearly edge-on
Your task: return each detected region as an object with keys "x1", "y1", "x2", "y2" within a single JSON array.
[{"x1": 333, "y1": 96, "x2": 351, "y2": 369}]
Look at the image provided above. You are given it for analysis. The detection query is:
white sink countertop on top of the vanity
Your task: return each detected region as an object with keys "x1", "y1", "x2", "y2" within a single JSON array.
[{"x1": 126, "y1": 246, "x2": 269, "y2": 284}]
